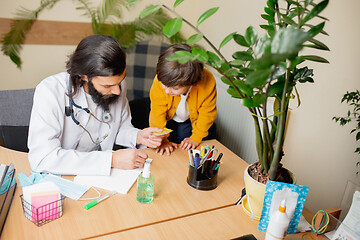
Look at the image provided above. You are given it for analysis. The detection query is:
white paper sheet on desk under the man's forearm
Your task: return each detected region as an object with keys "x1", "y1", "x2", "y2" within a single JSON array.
[{"x1": 74, "y1": 168, "x2": 142, "y2": 194}]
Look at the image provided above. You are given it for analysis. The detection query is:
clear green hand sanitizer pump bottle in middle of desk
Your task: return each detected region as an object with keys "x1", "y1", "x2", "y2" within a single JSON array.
[{"x1": 136, "y1": 162, "x2": 155, "y2": 203}]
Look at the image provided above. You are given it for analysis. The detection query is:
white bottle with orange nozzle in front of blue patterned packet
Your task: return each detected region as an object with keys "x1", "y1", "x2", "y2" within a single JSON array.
[{"x1": 265, "y1": 200, "x2": 290, "y2": 240}]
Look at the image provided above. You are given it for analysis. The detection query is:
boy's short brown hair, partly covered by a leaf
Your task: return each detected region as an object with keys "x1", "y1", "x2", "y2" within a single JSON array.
[{"x1": 156, "y1": 44, "x2": 204, "y2": 87}]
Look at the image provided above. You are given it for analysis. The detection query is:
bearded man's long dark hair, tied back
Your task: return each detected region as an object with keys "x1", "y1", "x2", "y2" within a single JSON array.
[{"x1": 66, "y1": 35, "x2": 126, "y2": 96}]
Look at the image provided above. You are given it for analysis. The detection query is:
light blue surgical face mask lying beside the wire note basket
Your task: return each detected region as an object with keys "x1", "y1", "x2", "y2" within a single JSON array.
[{"x1": 40, "y1": 174, "x2": 90, "y2": 200}]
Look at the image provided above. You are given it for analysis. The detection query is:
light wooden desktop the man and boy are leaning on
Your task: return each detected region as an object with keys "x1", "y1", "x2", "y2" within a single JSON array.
[{"x1": 0, "y1": 140, "x2": 248, "y2": 239}]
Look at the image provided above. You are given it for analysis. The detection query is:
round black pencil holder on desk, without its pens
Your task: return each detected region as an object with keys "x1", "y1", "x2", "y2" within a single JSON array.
[{"x1": 187, "y1": 161, "x2": 219, "y2": 190}]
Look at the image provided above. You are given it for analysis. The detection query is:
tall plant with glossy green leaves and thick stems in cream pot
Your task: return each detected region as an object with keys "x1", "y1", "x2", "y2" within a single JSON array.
[{"x1": 134, "y1": 0, "x2": 329, "y2": 218}]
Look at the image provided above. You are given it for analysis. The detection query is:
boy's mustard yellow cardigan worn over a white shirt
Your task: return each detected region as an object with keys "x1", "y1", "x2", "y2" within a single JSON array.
[{"x1": 149, "y1": 68, "x2": 217, "y2": 143}]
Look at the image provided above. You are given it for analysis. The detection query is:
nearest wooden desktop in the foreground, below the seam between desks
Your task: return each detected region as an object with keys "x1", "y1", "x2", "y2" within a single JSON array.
[{"x1": 90, "y1": 205, "x2": 312, "y2": 240}]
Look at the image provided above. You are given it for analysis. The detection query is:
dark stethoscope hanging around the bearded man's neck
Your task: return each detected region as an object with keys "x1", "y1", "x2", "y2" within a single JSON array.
[{"x1": 65, "y1": 77, "x2": 112, "y2": 145}]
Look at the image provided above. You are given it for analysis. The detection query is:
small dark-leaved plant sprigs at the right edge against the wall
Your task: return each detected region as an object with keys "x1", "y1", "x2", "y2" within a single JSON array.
[{"x1": 333, "y1": 90, "x2": 360, "y2": 179}]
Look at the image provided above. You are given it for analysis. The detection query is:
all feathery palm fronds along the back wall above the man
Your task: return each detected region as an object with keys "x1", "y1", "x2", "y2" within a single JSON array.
[{"x1": 0, "y1": 0, "x2": 183, "y2": 68}]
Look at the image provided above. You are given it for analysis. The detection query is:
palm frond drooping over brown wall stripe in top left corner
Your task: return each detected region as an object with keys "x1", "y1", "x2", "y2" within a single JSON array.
[{"x1": 1, "y1": 0, "x2": 60, "y2": 69}]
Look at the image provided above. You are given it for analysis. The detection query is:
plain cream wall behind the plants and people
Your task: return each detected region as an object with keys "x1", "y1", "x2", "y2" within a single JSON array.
[{"x1": 0, "y1": 0, "x2": 360, "y2": 214}]
